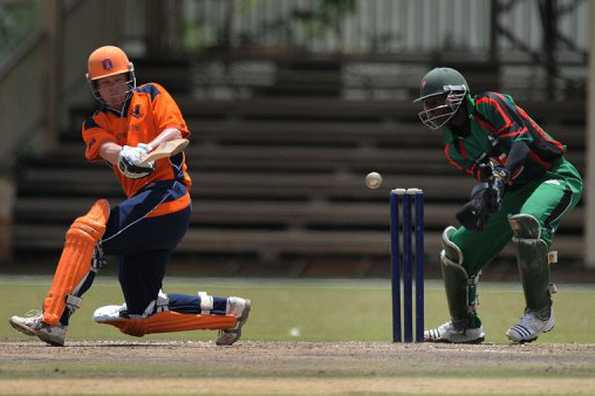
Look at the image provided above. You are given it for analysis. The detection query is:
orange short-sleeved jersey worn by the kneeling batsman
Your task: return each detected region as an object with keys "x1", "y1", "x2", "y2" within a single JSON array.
[{"x1": 82, "y1": 83, "x2": 191, "y2": 200}]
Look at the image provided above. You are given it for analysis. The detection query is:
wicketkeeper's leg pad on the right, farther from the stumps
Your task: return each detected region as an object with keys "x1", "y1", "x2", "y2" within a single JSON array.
[{"x1": 508, "y1": 213, "x2": 552, "y2": 312}]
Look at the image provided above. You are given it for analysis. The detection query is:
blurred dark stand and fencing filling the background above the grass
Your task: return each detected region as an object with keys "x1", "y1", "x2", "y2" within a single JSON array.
[{"x1": 0, "y1": 0, "x2": 595, "y2": 280}]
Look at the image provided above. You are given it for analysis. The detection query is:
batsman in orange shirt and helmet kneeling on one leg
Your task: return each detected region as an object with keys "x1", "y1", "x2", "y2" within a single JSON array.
[{"x1": 9, "y1": 46, "x2": 251, "y2": 346}]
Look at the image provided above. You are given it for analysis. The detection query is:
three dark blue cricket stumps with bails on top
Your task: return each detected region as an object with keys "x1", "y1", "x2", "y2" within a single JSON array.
[{"x1": 390, "y1": 188, "x2": 424, "y2": 342}]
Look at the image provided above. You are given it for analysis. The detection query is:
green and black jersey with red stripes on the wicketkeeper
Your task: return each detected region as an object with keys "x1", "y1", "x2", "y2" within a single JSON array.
[{"x1": 443, "y1": 92, "x2": 566, "y2": 186}]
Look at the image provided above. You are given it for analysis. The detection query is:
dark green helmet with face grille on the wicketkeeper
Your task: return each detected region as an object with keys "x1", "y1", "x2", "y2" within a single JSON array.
[{"x1": 414, "y1": 67, "x2": 469, "y2": 129}]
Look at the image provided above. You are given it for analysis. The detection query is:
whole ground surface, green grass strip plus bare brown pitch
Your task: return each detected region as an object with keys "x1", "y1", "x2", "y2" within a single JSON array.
[{"x1": 0, "y1": 276, "x2": 595, "y2": 396}]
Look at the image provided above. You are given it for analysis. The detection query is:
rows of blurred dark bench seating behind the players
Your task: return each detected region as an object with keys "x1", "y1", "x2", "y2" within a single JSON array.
[{"x1": 14, "y1": 69, "x2": 585, "y2": 276}]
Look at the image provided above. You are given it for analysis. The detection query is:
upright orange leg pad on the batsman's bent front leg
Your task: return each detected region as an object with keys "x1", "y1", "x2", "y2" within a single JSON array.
[{"x1": 43, "y1": 199, "x2": 110, "y2": 326}]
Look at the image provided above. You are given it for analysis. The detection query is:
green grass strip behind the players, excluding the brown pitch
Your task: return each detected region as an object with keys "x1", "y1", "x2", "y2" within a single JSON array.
[{"x1": 0, "y1": 276, "x2": 595, "y2": 343}]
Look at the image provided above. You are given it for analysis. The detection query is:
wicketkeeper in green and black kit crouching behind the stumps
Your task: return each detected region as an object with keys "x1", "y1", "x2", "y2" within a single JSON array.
[{"x1": 415, "y1": 67, "x2": 583, "y2": 343}]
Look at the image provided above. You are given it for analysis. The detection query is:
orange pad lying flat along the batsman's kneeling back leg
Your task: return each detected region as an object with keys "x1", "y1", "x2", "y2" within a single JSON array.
[{"x1": 93, "y1": 305, "x2": 237, "y2": 337}]
